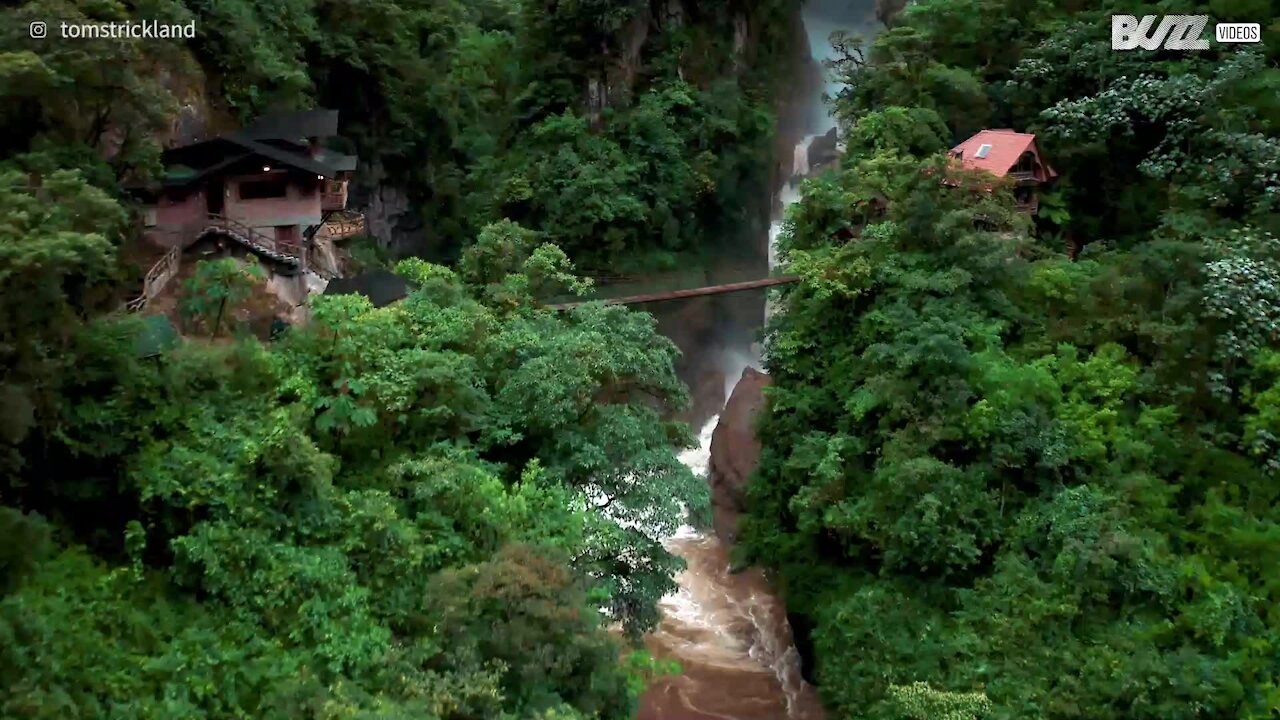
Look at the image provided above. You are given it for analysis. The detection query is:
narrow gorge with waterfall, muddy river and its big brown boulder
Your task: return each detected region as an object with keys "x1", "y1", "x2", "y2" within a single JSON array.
[{"x1": 639, "y1": 0, "x2": 884, "y2": 720}]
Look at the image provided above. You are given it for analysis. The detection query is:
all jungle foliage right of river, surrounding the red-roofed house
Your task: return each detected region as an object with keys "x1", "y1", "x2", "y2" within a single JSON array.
[{"x1": 744, "y1": 0, "x2": 1280, "y2": 720}]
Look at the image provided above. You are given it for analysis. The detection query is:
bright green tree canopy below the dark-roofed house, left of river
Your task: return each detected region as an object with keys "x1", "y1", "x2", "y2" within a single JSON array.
[{"x1": 0, "y1": 227, "x2": 705, "y2": 719}]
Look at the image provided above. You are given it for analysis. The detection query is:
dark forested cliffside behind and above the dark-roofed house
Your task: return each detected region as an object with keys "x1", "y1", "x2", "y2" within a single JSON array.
[{"x1": 0, "y1": 0, "x2": 792, "y2": 270}]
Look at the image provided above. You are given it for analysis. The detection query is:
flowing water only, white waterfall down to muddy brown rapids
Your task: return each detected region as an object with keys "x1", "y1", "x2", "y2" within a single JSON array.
[{"x1": 639, "y1": 0, "x2": 879, "y2": 720}]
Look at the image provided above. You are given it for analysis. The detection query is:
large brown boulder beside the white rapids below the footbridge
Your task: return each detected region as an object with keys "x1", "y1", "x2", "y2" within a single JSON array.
[{"x1": 707, "y1": 368, "x2": 772, "y2": 543}]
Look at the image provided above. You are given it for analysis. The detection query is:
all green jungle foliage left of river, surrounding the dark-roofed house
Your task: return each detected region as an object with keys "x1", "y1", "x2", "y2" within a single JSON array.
[{"x1": 0, "y1": 0, "x2": 792, "y2": 720}]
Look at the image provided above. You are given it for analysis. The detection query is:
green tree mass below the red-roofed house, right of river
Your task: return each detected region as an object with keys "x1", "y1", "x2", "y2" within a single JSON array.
[{"x1": 742, "y1": 140, "x2": 1280, "y2": 720}]
